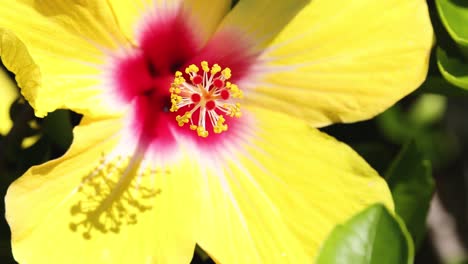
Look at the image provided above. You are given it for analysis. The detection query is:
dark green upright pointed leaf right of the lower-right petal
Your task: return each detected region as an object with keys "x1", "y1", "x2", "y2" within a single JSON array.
[{"x1": 385, "y1": 141, "x2": 434, "y2": 249}]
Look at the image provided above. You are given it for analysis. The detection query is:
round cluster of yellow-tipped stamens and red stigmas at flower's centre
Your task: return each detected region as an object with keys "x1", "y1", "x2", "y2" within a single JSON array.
[{"x1": 169, "y1": 61, "x2": 243, "y2": 138}]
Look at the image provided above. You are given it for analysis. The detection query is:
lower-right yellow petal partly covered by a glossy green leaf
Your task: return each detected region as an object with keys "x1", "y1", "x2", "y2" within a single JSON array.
[{"x1": 197, "y1": 106, "x2": 393, "y2": 263}]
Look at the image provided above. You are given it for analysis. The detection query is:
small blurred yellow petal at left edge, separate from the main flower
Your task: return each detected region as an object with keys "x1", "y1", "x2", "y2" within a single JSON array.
[{"x1": 0, "y1": 69, "x2": 18, "y2": 135}]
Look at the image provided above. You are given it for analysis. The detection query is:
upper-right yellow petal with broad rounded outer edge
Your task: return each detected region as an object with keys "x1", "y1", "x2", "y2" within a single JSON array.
[{"x1": 246, "y1": 0, "x2": 433, "y2": 127}]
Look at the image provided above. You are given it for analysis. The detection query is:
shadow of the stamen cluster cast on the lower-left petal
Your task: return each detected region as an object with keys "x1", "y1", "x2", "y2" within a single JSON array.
[{"x1": 69, "y1": 156, "x2": 165, "y2": 239}]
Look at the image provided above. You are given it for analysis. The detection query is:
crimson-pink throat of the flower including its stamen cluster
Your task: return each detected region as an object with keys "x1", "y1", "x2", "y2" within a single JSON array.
[{"x1": 112, "y1": 11, "x2": 256, "y2": 149}]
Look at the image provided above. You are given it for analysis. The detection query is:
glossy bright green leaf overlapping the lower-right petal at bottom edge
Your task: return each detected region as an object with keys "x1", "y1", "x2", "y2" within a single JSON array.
[{"x1": 316, "y1": 204, "x2": 414, "y2": 264}]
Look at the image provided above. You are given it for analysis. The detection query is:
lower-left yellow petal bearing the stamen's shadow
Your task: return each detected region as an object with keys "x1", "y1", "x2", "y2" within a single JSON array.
[{"x1": 5, "y1": 120, "x2": 198, "y2": 263}]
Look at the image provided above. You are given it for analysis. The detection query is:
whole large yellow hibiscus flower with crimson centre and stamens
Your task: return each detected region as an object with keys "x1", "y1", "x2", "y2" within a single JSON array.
[{"x1": 0, "y1": 0, "x2": 433, "y2": 263}]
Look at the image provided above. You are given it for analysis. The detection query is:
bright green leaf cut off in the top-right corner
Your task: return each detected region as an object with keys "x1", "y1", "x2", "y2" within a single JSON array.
[{"x1": 436, "y1": 0, "x2": 468, "y2": 54}]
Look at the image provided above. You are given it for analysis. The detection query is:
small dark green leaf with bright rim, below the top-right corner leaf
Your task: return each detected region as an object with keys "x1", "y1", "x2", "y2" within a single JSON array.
[{"x1": 437, "y1": 47, "x2": 468, "y2": 89}]
